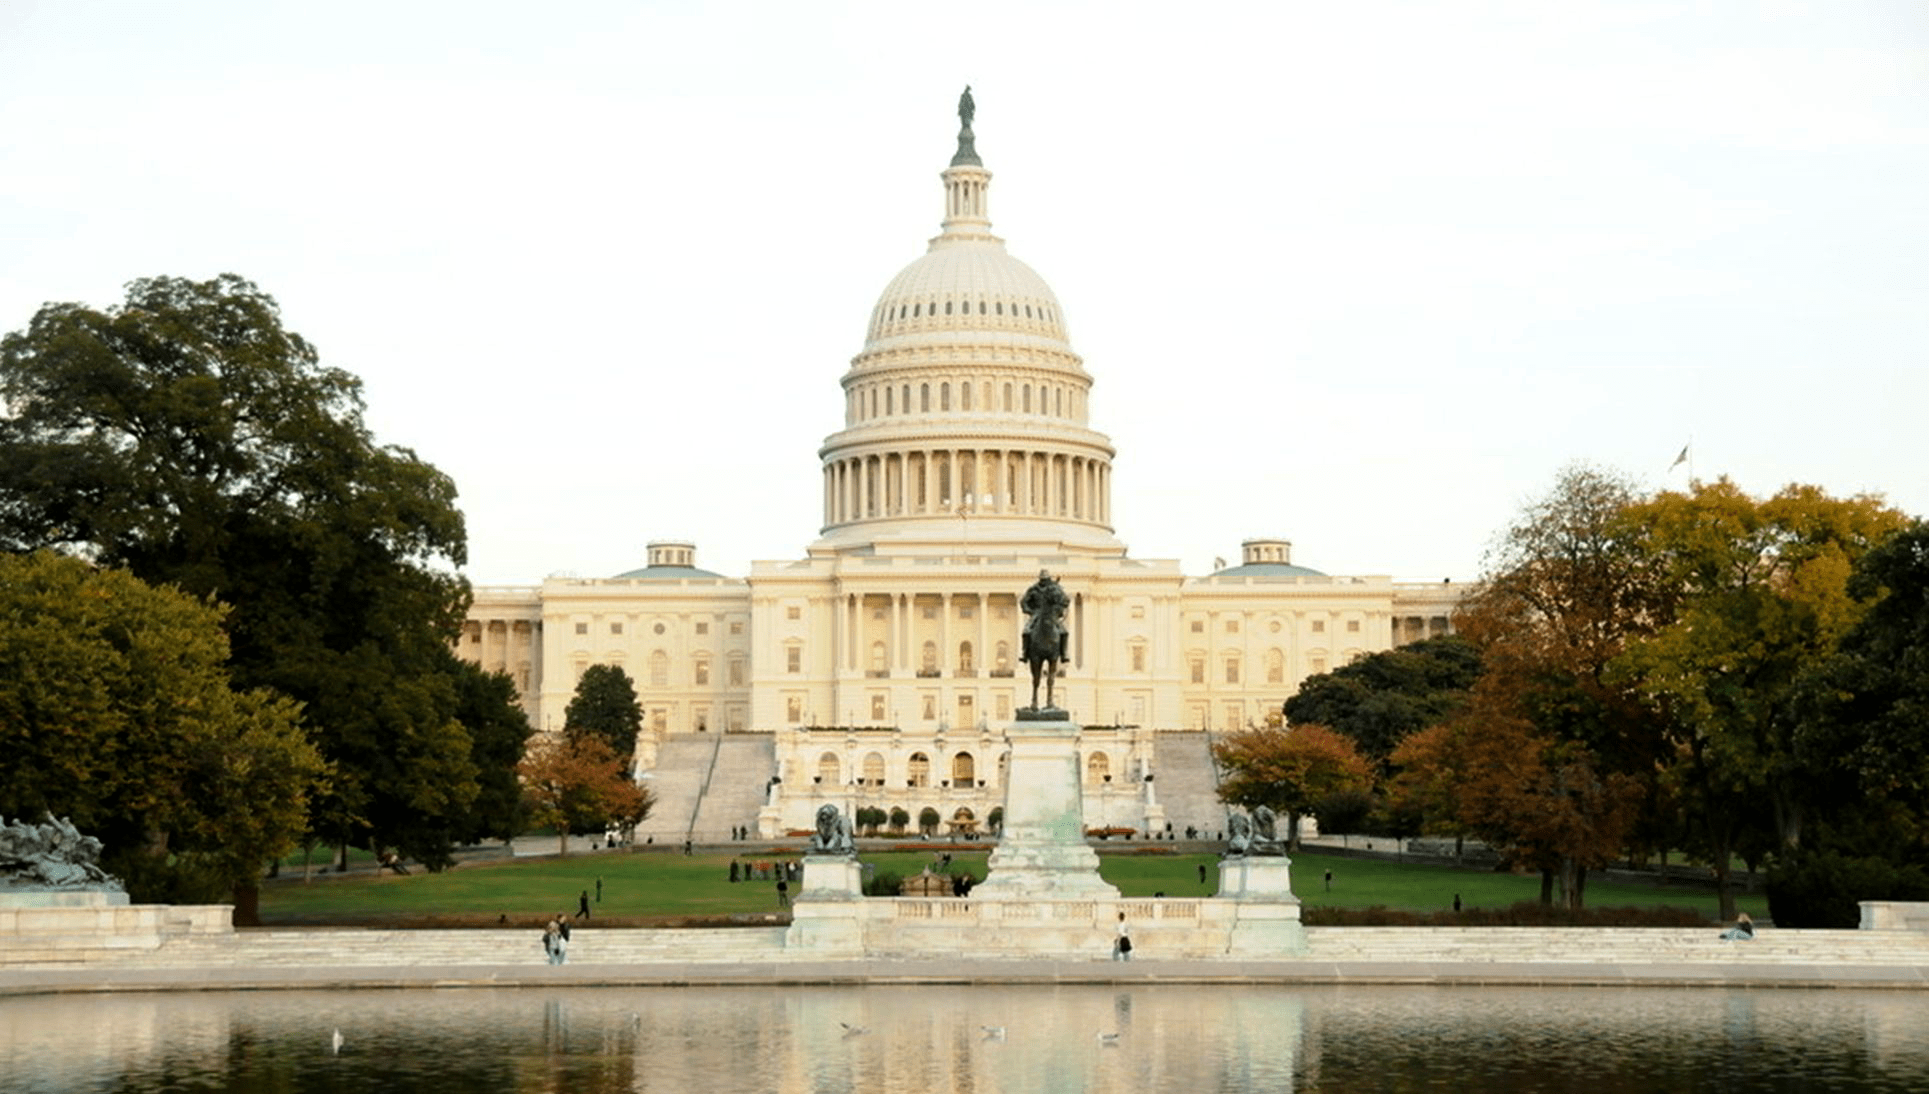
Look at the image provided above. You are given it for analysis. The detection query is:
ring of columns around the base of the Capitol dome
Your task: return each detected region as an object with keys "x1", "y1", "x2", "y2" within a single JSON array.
[{"x1": 824, "y1": 450, "x2": 1111, "y2": 527}]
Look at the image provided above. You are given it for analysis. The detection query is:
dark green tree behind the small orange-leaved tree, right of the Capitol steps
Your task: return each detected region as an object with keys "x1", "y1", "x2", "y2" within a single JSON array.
[{"x1": 1285, "y1": 635, "x2": 1480, "y2": 774}]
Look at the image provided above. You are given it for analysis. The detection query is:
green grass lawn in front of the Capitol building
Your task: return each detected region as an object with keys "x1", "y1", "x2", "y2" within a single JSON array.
[{"x1": 260, "y1": 851, "x2": 1767, "y2": 924}]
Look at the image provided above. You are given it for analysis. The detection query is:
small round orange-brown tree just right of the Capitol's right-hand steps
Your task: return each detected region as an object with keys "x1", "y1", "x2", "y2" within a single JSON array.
[{"x1": 1211, "y1": 725, "x2": 1373, "y2": 851}]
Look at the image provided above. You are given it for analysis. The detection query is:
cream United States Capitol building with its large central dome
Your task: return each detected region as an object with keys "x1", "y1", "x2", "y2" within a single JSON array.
[{"x1": 459, "y1": 104, "x2": 1462, "y2": 839}]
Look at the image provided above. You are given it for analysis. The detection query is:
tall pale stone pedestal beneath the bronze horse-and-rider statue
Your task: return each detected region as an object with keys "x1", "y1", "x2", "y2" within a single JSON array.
[{"x1": 970, "y1": 710, "x2": 1119, "y2": 901}]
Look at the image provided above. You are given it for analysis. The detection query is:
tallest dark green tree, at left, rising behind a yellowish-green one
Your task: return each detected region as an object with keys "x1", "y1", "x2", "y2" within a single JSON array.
[{"x1": 0, "y1": 274, "x2": 476, "y2": 872}]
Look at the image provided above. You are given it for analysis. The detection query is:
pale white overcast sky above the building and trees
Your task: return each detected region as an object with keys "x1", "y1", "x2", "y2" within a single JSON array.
[{"x1": 0, "y1": 0, "x2": 1929, "y2": 585}]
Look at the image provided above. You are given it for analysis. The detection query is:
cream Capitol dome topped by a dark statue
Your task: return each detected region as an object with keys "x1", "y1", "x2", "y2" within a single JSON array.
[{"x1": 818, "y1": 96, "x2": 1123, "y2": 550}]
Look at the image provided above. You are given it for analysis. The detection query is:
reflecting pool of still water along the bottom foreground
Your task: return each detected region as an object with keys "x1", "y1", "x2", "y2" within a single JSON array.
[{"x1": 0, "y1": 986, "x2": 1929, "y2": 1094}]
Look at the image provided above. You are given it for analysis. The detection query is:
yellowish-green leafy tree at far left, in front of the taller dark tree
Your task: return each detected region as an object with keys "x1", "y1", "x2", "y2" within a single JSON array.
[{"x1": 0, "y1": 552, "x2": 324, "y2": 916}]
